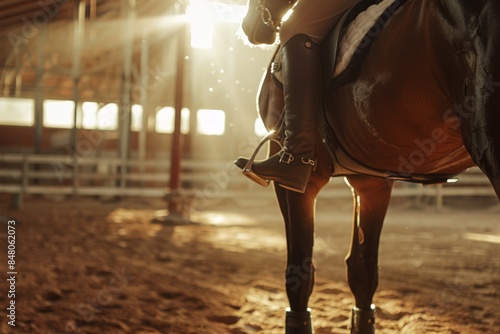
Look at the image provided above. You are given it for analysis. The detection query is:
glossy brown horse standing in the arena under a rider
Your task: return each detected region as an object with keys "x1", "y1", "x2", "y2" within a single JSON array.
[{"x1": 237, "y1": 0, "x2": 500, "y2": 334}]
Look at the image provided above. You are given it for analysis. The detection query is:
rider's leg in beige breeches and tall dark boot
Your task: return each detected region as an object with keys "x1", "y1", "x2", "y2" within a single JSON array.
[{"x1": 238, "y1": 0, "x2": 359, "y2": 193}]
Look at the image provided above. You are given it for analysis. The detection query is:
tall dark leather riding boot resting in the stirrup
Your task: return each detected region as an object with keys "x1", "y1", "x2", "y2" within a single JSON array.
[{"x1": 236, "y1": 34, "x2": 323, "y2": 193}]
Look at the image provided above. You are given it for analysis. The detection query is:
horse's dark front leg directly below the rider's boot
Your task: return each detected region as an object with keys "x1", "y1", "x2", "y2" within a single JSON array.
[{"x1": 275, "y1": 153, "x2": 329, "y2": 334}]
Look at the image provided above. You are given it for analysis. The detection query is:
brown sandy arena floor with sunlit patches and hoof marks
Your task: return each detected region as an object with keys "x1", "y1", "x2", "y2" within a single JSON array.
[{"x1": 0, "y1": 196, "x2": 500, "y2": 334}]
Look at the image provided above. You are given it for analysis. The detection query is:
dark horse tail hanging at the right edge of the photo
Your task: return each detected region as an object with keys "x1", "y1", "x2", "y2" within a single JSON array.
[{"x1": 458, "y1": 0, "x2": 500, "y2": 198}]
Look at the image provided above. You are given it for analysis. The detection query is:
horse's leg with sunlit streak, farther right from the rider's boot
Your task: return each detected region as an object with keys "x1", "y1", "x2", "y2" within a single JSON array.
[{"x1": 346, "y1": 176, "x2": 393, "y2": 334}]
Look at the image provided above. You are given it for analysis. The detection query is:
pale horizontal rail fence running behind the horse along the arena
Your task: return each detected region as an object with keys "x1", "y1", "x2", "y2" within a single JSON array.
[{"x1": 0, "y1": 154, "x2": 495, "y2": 207}]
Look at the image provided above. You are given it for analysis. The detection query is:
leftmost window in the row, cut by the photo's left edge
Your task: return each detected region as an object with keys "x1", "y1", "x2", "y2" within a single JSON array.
[{"x1": 0, "y1": 97, "x2": 35, "y2": 126}]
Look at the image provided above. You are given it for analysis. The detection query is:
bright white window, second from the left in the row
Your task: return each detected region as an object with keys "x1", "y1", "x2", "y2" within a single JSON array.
[{"x1": 43, "y1": 100, "x2": 75, "y2": 129}]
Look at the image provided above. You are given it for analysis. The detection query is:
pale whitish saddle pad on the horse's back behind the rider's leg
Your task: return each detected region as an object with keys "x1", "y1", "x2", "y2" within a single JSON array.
[{"x1": 333, "y1": 0, "x2": 399, "y2": 76}]
